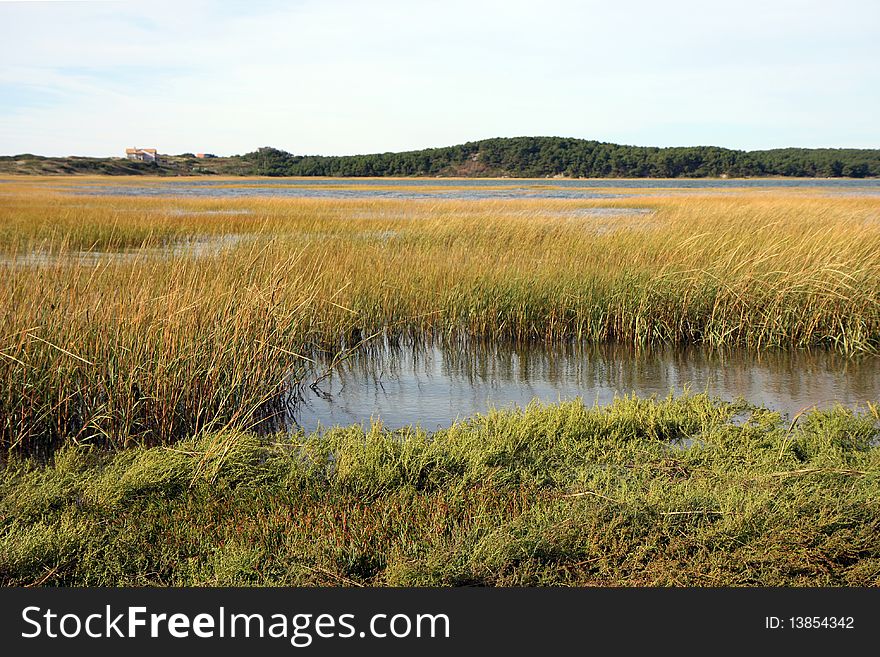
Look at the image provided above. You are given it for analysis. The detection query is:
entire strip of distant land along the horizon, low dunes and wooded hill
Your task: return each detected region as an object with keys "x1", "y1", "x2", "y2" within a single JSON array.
[{"x1": 0, "y1": 137, "x2": 880, "y2": 178}]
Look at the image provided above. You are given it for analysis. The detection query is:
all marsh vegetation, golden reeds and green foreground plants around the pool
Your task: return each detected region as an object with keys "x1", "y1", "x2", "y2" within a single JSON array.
[{"x1": 0, "y1": 178, "x2": 880, "y2": 586}]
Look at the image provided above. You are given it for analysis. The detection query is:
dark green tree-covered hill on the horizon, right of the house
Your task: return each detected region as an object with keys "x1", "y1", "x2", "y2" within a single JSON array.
[{"x1": 242, "y1": 137, "x2": 880, "y2": 178}]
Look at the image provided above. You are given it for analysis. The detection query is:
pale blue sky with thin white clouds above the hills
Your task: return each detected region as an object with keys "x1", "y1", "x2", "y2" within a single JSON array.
[{"x1": 0, "y1": 0, "x2": 880, "y2": 156}]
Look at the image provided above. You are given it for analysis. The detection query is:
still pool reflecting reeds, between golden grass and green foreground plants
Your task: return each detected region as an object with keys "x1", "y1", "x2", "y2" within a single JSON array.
[{"x1": 290, "y1": 345, "x2": 880, "y2": 431}]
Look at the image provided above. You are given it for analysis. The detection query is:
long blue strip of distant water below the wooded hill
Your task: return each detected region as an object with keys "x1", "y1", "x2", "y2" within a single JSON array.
[{"x1": 66, "y1": 178, "x2": 880, "y2": 200}]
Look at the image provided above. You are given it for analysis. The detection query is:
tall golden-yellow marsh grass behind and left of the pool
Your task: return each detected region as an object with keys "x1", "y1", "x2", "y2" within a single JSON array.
[{"x1": 0, "y1": 178, "x2": 880, "y2": 452}]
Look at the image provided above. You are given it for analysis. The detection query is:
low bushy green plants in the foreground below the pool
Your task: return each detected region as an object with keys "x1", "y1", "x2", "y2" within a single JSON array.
[{"x1": 0, "y1": 396, "x2": 880, "y2": 586}]
